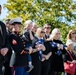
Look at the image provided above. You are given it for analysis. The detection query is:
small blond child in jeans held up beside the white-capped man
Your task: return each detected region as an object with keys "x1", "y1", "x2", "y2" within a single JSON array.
[{"x1": 23, "y1": 20, "x2": 34, "y2": 72}]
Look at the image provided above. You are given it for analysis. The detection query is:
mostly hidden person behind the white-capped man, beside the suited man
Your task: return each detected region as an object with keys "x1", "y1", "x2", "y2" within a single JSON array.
[{"x1": 4, "y1": 19, "x2": 12, "y2": 75}]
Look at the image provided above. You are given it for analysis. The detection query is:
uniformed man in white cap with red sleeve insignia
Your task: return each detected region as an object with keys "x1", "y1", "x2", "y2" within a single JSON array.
[{"x1": 9, "y1": 18, "x2": 32, "y2": 75}]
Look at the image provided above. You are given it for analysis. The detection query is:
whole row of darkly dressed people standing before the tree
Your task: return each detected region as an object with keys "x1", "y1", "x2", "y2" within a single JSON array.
[{"x1": 0, "y1": 6, "x2": 76, "y2": 75}]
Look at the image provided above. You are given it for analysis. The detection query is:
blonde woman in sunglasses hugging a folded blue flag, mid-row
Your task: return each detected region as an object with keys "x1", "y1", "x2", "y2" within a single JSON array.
[{"x1": 30, "y1": 28, "x2": 45, "y2": 75}]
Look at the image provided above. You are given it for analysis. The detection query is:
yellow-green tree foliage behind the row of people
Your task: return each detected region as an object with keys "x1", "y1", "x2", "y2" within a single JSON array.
[{"x1": 5, "y1": 0, "x2": 76, "y2": 42}]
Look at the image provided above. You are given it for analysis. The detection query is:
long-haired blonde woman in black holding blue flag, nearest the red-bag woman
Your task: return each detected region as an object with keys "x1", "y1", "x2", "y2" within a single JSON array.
[{"x1": 50, "y1": 28, "x2": 66, "y2": 75}]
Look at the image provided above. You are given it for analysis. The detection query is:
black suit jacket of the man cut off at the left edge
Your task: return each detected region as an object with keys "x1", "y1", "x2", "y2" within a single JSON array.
[{"x1": 0, "y1": 21, "x2": 9, "y2": 61}]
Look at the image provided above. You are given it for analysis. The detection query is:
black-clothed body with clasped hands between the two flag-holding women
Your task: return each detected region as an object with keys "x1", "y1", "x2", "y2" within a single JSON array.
[{"x1": 41, "y1": 33, "x2": 52, "y2": 75}]
